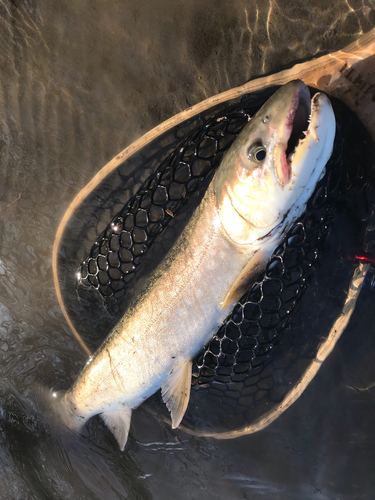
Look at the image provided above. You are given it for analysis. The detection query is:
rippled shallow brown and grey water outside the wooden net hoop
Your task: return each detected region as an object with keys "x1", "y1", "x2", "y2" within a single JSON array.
[{"x1": 0, "y1": 0, "x2": 375, "y2": 500}]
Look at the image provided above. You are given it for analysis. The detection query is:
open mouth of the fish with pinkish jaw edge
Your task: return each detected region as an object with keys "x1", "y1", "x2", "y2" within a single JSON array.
[{"x1": 276, "y1": 80, "x2": 314, "y2": 186}]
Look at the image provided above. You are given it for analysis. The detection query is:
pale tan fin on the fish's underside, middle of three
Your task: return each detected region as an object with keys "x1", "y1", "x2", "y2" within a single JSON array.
[{"x1": 161, "y1": 360, "x2": 193, "y2": 429}]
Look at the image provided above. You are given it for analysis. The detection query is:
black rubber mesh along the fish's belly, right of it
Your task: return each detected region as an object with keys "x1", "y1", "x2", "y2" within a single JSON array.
[{"x1": 193, "y1": 166, "x2": 342, "y2": 388}]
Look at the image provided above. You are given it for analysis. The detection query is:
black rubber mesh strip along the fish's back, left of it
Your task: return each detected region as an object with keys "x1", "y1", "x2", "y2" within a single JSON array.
[{"x1": 80, "y1": 106, "x2": 250, "y2": 304}]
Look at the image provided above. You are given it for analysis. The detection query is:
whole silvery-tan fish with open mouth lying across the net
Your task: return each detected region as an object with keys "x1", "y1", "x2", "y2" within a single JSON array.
[{"x1": 59, "y1": 80, "x2": 336, "y2": 451}]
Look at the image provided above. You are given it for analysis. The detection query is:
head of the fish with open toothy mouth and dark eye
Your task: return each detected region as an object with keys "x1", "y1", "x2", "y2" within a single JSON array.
[{"x1": 213, "y1": 80, "x2": 336, "y2": 244}]
